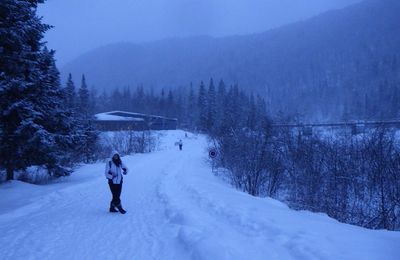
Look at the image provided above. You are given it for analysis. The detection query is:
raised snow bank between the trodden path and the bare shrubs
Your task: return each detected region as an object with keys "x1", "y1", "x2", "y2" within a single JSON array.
[{"x1": 159, "y1": 133, "x2": 400, "y2": 259}]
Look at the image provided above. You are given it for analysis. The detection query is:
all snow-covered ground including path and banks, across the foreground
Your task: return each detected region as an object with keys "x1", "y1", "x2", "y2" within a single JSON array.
[{"x1": 0, "y1": 131, "x2": 400, "y2": 260}]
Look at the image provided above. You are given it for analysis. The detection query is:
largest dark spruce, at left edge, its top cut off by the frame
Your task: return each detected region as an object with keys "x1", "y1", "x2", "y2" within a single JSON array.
[{"x1": 0, "y1": 0, "x2": 74, "y2": 180}]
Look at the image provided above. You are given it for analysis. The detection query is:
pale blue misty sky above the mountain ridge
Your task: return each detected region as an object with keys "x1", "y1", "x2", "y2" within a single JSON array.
[{"x1": 39, "y1": 0, "x2": 360, "y2": 66}]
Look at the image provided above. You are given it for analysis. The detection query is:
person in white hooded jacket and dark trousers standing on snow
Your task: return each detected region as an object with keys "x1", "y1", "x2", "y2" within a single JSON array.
[{"x1": 105, "y1": 152, "x2": 128, "y2": 214}]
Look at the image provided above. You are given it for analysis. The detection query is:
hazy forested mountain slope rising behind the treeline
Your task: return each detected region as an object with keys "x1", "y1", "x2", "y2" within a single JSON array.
[{"x1": 62, "y1": 0, "x2": 400, "y2": 121}]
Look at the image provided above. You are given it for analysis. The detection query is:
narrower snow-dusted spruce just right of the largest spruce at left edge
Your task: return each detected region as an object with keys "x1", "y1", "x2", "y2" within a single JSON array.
[{"x1": 33, "y1": 48, "x2": 76, "y2": 176}]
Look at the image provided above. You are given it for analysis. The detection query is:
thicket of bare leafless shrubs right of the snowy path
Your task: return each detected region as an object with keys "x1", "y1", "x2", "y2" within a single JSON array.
[{"x1": 213, "y1": 116, "x2": 400, "y2": 230}]
